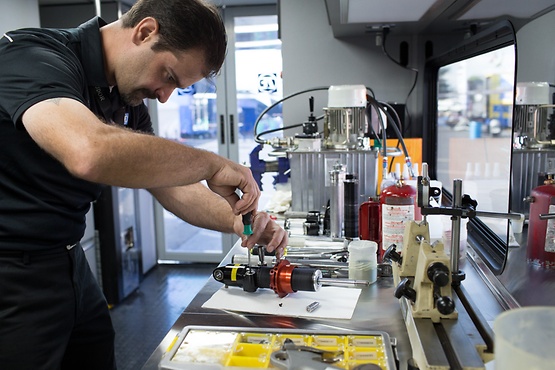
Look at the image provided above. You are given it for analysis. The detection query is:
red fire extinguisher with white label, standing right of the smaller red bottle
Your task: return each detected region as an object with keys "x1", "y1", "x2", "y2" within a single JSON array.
[{"x1": 380, "y1": 178, "x2": 422, "y2": 257}]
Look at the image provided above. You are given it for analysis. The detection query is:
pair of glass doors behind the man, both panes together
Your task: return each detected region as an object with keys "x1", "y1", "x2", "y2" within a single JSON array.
[{"x1": 150, "y1": 6, "x2": 282, "y2": 262}]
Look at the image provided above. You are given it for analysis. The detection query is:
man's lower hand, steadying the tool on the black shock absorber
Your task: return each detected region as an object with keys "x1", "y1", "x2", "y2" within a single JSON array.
[{"x1": 241, "y1": 212, "x2": 289, "y2": 258}]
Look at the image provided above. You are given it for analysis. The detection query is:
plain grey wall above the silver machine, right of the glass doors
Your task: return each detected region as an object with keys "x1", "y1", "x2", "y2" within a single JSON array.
[{"x1": 279, "y1": 1, "x2": 415, "y2": 135}]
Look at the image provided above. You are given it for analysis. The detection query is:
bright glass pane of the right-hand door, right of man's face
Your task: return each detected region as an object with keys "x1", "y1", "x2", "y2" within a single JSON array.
[{"x1": 226, "y1": 6, "x2": 283, "y2": 209}]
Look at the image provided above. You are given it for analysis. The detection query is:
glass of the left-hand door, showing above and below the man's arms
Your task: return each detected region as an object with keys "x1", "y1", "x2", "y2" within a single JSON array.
[{"x1": 150, "y1": 80, "x2": 232, "y2": 262}]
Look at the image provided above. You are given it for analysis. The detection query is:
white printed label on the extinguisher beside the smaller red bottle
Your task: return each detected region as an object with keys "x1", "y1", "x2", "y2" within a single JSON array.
[{"x1": 382, "y1": 204, "x2": 414, "y2": 251}]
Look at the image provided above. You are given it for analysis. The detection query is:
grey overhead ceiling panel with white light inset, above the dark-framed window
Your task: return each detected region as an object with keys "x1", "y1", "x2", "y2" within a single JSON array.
[{"x1": 324, "y1": 0, "x2": 555, "y2": 37}]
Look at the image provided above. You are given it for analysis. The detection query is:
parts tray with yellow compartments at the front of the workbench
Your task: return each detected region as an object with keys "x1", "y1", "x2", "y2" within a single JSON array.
[{"x1": 160, "y1": 326, "x2": 396, "y2": 370}]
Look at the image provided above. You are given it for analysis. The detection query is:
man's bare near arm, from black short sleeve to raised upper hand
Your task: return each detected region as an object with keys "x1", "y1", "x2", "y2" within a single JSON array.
[{"x1": 22, "y1": 98, "x2": 260, "y2": 214}]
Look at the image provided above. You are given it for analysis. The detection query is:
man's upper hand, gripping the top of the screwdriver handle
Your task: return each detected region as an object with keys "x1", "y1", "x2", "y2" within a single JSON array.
[{"x1": 206, "y1": 158, "x2": 260, "y2": 215}]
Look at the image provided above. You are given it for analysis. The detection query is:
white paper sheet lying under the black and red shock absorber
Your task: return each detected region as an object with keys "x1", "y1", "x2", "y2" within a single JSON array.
[{"x1": 202, "y1": 287, "x2": 361, "y2": 320}]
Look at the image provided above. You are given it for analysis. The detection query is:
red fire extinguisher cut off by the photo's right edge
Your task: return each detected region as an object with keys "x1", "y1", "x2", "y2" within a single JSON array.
[{"x1": 526, "y1": 175, "x2": 555, "y2": 269}]
